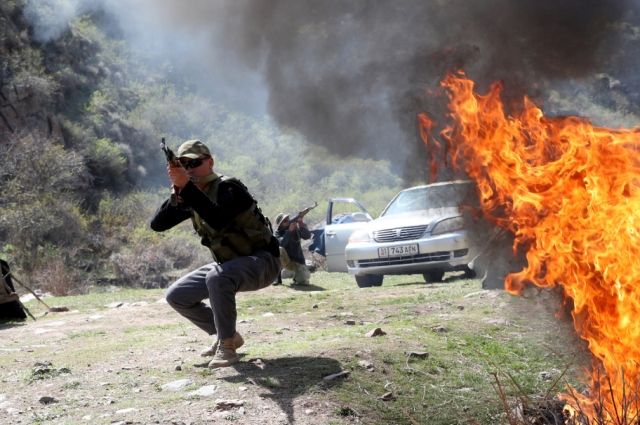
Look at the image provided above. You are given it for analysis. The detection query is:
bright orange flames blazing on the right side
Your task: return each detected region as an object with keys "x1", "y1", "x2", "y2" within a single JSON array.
[{"x1": 420, "y1": 73, "x2": 640, "y2": 424}]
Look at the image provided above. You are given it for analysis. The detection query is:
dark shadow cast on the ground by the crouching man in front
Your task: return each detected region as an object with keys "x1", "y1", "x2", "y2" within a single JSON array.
[{"x1": 222, "y1": 357, "x2": 344, "y2": 423}]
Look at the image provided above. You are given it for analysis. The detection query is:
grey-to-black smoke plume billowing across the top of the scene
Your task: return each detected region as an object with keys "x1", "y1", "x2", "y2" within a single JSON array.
[{"x1": 25, "y1": 0, "x2": 640, "y2": 179}]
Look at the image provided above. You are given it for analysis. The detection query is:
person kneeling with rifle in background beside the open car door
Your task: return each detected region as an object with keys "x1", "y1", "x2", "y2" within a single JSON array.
[{"x1": 276, "y1": 213, "x2": 311, "y2": 285}]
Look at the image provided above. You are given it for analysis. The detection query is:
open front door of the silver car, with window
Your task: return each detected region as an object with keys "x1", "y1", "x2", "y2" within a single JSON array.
[{"x1": 323, "y1": 198, "x2": 373, "y2": 272}]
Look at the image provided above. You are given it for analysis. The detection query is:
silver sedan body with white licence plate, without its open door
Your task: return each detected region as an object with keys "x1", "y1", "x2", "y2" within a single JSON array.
[{"x1": 345, "y1": 181, "x2": 474, "y2": 287}]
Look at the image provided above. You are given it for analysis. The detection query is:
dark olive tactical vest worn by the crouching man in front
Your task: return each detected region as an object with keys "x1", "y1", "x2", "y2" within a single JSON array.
[{"x1": 191, "y1": 176, "x2": 272, "y2": 263}]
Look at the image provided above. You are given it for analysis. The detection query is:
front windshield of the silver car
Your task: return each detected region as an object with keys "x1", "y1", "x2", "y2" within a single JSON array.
[{"x1": 382, "y1": 184, "x2": 471, "y2": 216}]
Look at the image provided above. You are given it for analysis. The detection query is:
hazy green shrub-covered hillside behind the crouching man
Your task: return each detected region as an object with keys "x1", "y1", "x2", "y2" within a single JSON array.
[{"x1": 0, "y1": 0, "x2": 402, "y2": 294}]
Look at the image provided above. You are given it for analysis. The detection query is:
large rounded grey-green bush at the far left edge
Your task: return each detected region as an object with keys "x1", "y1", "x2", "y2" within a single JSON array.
[{"x1": 0, "y1": 137, "x2": 86, "y2": 270}]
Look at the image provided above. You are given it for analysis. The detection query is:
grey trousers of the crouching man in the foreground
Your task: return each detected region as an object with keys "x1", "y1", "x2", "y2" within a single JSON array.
[{"x1": 166, "y1": 251, "x2": 280, "y2": 339}]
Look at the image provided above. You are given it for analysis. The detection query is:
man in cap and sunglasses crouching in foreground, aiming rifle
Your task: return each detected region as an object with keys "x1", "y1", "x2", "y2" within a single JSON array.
[{"x1": 151, "y1": 140, "x2": 280, "y2": 368}]
